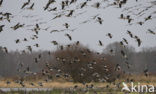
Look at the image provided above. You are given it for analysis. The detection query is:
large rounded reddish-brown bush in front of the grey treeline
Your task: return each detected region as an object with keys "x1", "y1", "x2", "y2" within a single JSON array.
[{"x1": 52, "y1": 44, "x2": 114, "y2": 83}]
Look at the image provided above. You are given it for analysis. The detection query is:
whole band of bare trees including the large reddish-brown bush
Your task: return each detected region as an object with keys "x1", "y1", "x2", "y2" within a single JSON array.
[{"x1": 0, "y1": 42, "x2": 156, "y2": 82}]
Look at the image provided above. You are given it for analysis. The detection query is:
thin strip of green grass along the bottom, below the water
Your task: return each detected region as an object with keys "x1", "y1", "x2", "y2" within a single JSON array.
[{"x1": 0, "y1": 89, "x2": 153, "y2": 94}]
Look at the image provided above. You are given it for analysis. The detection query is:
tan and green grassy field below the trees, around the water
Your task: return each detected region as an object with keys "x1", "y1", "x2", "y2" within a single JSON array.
[{"x1": 0, "y1": 75, "x2": 156, "y2": 94}]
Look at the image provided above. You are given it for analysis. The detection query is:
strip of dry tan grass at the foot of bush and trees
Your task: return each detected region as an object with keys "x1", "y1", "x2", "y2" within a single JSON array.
[{"x1": 0, "y1": 75, "x2": 156, "y2": 88}]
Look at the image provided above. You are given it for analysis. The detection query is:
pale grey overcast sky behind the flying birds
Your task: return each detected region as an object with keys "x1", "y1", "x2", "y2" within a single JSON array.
[{"x1": 0, "y1": 0, "x2": 156, "y2": 51}]
